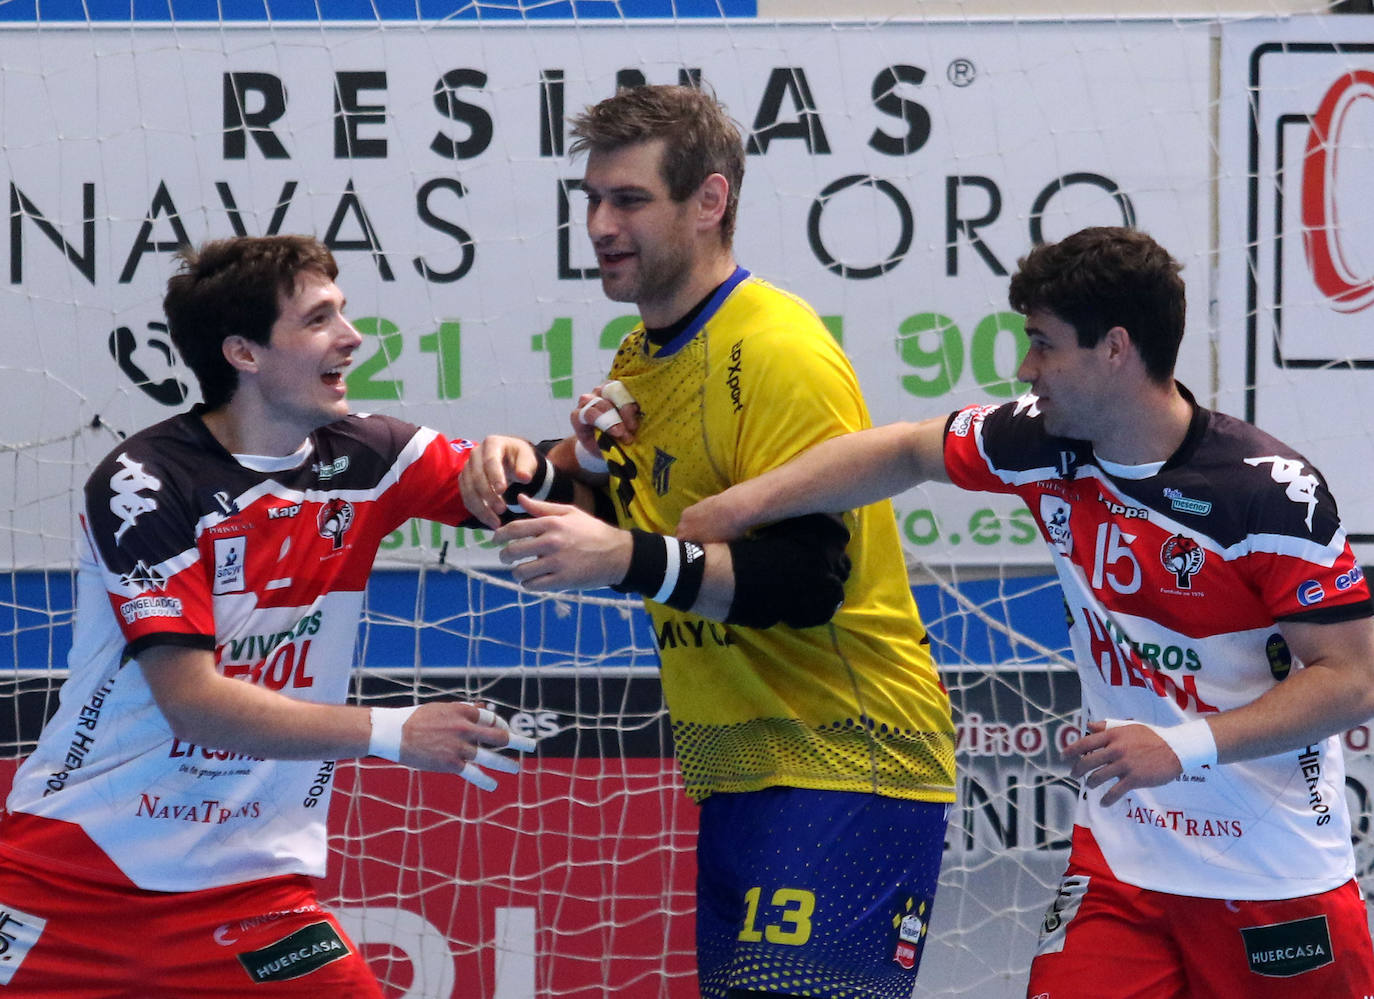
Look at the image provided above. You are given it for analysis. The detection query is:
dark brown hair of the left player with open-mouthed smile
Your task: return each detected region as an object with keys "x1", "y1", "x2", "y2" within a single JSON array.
[{"x1": 162, "y1": 235, "x2": 339, "y2": 409}]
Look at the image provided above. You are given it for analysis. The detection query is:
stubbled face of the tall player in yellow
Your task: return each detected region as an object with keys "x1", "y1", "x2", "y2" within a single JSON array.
[{"x1": 583, "y1": 139, "x2": 702, "y2": 326}]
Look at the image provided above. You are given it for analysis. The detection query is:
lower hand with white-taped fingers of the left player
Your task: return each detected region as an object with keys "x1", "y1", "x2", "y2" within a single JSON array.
[{"x1": 401, "y1": 701, "x2": 536, "y2": 792}]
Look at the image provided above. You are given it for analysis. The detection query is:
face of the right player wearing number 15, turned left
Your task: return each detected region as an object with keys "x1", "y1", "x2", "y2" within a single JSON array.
[{"x1": 1017, "y1": 309, "x2": 1124, "y2": 441}]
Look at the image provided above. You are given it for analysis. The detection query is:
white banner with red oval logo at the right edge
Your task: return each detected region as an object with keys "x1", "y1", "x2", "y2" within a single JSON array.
[{"x1": 1217, "y1": 16, "x2": 1374, "y2": 558}]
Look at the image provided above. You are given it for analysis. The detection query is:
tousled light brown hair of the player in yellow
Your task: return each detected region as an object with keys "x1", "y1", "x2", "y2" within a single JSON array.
[{"x1": 572, "y1": 85, "x2": 745, "y2": 246}]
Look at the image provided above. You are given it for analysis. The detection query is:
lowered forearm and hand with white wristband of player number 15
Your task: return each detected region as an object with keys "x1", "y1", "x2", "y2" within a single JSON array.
[{"x1": 1066, "y1": 617, "x2": 1374, "y2": 805}]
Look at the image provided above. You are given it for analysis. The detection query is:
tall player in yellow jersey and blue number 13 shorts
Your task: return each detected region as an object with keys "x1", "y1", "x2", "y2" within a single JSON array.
[{"x1": 462, "y1": 87, "x2": 954, "y2": 999}]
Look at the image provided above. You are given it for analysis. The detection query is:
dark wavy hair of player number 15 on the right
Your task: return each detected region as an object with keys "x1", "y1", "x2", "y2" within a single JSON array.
[{"x1": 1007, "y1": 225, "x2": 1187, "y2": 382}]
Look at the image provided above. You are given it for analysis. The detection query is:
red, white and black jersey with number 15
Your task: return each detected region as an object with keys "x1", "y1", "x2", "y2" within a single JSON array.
[{"x1": 944, "y1": 386, "x2": 1374, "y2": 899}]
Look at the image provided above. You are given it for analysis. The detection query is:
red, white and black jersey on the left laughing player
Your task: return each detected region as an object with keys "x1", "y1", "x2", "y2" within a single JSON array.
[{"x1": 0, "y1": 412, "x2": 471, "y2": 892}]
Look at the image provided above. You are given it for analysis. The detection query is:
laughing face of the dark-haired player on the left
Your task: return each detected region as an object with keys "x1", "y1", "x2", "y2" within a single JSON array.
[{"x1": 227, "y1": 271, "x2": 363, "y2": 453}]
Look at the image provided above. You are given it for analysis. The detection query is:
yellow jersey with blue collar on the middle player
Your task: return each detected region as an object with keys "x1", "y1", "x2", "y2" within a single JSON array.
[{"x1": 606, "y1": 269, "x2": 954, "y2": 801}]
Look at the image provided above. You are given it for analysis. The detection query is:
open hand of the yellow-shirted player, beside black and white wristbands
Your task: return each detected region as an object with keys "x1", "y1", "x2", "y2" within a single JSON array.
[{"x1": 493, "y1": 495, "x2": 633, "y2": 591}]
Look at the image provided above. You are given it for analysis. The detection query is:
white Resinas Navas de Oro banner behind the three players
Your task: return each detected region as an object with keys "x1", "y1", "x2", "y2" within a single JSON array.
[{"x1": 0, "y1": 22, "x2": 1210, "y2": 566}]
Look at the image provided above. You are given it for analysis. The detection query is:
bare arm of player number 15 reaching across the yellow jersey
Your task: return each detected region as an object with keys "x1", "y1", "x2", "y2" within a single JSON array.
[{"x1": 677, "y1": 416, "x2": 949, "y2": 541}]
